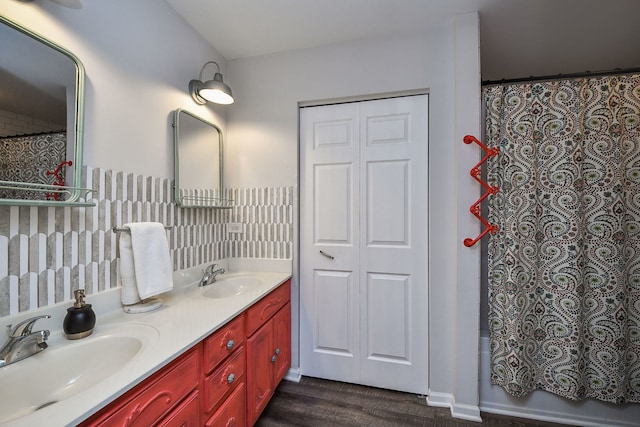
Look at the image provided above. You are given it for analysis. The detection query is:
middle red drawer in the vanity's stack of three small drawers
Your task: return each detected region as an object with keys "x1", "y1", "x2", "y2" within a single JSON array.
[{"x1": 204, "y1": 347, "x2": 247, "y2": 413}]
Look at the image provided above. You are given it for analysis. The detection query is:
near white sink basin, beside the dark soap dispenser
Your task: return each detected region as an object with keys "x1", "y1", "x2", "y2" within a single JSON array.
[{"x1": 0, "y1": 324, "x2": 159, "y2": 424}]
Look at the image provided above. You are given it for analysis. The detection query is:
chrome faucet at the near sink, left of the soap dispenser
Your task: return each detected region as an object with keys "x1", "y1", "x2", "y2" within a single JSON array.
[{"x1": 0, "y1": 314, "x2": 51, "y2": 368}]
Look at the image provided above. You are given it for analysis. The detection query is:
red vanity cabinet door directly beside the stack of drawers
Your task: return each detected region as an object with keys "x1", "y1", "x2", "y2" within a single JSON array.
[{"x1": 247, "y1": 319, "x2": 274, "y2": 425}]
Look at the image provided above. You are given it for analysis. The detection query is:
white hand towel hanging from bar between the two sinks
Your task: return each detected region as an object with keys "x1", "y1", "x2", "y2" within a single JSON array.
[{"x1": 120, "y1": 222, "x2": 173, "y2": 303}]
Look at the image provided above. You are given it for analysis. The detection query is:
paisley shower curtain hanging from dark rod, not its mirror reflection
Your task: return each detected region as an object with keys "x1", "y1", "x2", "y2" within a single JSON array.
[{"x1": 483, "y1": 74, "x2": 640, "y2": 403}]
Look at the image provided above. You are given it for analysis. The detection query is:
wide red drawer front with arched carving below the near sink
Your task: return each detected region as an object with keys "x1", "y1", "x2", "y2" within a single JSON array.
[{"x1": 91, "y1": 347, "x2": 201, "y2": 427}]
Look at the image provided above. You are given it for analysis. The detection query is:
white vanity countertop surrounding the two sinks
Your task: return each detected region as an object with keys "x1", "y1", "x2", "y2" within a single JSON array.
[{"x1": 0, "y1": 259, "x2": 291, "y2": 426}]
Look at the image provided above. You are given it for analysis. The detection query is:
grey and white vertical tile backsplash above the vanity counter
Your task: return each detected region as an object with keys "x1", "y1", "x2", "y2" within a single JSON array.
[{"x1": 0, "y1": 167, "x2": 293, "y2": 317}]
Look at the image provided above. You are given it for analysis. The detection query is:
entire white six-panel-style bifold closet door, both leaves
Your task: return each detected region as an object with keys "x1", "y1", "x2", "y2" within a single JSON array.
[{"x1": 300, "y1": 95, "x2": 428, "y2": 393}]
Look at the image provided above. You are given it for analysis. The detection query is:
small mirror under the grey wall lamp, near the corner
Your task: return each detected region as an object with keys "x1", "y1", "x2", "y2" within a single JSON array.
[{"x1": 173, "y1": 108, "x2": 230, "y2": 208}]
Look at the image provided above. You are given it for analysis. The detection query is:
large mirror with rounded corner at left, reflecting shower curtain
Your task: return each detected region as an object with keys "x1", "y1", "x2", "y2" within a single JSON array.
[{"x1": 0, "y1": 15, "x2": 93, "y2": 206}]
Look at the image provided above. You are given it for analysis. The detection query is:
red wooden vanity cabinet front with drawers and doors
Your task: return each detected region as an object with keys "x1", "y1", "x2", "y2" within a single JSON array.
[{"x1": 80, "y1": 280, "x2": 291, "y2": 427}]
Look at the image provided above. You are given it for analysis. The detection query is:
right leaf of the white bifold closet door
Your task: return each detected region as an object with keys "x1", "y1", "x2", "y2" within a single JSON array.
[{"x1": 359, "y1": 96, "x2": 429, "y2": 393}]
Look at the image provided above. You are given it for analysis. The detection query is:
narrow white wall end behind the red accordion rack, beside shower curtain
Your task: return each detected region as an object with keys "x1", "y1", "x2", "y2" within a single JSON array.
[{"x1": 452, "y1": 13, "x2": 484, "y2": 421}]
